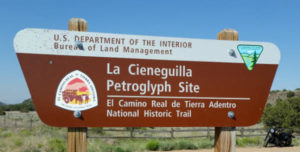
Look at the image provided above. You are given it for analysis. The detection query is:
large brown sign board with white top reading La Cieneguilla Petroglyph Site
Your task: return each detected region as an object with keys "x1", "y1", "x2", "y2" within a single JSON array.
[{"x1": 14, "y1": 29, "x2": 280, "y2": 127}]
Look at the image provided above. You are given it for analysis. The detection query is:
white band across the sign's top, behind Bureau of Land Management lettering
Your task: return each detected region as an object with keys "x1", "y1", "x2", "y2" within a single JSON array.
[{"x1": 14, "y1": 28, "x2": 280, "y2": 64}]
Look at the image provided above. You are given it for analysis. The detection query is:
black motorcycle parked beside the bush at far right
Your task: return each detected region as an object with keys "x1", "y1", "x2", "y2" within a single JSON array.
[{"x1": 264, "y1": 127, "x2": 295, "y2": 147}]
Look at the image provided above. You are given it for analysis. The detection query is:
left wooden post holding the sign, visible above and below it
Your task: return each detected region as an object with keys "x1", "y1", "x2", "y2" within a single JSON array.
[{"x1": 68, "y1": 18, "x2": 87, "y2": 152}]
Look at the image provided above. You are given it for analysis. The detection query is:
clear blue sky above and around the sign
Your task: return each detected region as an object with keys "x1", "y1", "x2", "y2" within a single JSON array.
[{"x1": 0, "y1": 0, "x2": 300, "y2": 104}]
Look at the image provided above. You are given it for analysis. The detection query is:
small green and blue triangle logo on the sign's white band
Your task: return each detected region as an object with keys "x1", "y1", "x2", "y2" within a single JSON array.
[{"x1": 237, "y1": 44, "x2": 263, "y2": 71}]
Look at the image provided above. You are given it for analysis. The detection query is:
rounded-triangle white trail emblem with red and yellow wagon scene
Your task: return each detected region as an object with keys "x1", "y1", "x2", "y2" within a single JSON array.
[{"x1": 55, "y1": 70, "x2": 98, "y2": 111}]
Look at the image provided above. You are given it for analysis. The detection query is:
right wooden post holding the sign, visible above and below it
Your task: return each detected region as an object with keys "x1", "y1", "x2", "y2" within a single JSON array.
[{"x1": 214, "y1": 29, "x2": 239, "y2": 152}]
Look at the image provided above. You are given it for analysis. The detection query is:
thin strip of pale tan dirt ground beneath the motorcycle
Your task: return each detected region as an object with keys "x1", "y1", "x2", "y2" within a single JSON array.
[{"x1": 168, "y1": 146, "x2": 300, "y2": 152}]
